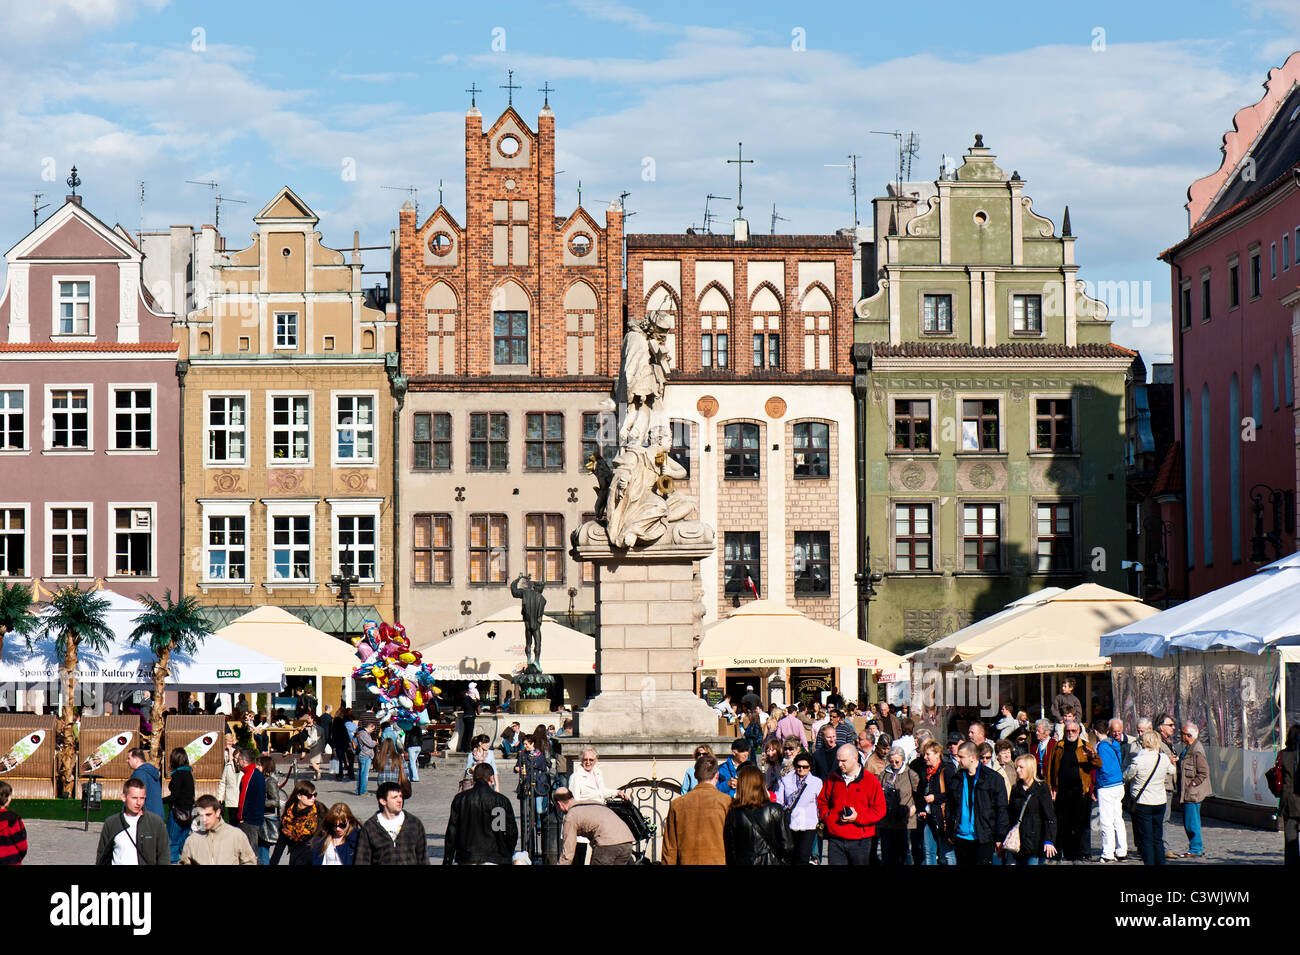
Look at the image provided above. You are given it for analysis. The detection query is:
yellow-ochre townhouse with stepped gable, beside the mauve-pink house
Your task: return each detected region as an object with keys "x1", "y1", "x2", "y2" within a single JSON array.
[{"x1": 177, "y1": 187, "x2": 400, "y2": 639}]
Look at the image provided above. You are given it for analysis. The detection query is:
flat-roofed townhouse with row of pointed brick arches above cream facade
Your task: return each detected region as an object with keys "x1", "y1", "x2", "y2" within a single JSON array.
[{"x1": 627, "y1": 220, "x2": 857, "y2": 701}]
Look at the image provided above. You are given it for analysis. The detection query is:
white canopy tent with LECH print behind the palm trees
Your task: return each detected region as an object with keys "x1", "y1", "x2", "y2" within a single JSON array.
[{"x1": 0, "y1": 590, "x2": 285, "y2": 696}]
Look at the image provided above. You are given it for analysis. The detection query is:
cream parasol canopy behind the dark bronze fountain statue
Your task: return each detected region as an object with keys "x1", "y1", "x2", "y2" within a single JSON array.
[{"x1": 417, "y1": 603, "x2": 595, "y2": 680}]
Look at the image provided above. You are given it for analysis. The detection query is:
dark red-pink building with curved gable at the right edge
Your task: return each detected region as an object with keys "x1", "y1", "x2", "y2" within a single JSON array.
[{"x1": 1161, "y1": 53, "x2": 1300, "y2": 598}]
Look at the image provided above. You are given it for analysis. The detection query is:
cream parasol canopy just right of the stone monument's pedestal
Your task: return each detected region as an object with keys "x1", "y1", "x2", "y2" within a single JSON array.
[{"x1": 697, "y1": 600, "x2": 904, "y2": 673}]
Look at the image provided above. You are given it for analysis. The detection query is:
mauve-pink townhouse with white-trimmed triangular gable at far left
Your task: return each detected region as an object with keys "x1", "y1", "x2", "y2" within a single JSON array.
[{"x1": 0, "y1": 196, "x2": 181, "y2": 596}]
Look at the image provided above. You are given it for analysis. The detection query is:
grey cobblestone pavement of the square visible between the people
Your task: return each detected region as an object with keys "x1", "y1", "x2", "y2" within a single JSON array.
[{"x1": 17, "y1": 754, "x2": 1282, "y2": 868}]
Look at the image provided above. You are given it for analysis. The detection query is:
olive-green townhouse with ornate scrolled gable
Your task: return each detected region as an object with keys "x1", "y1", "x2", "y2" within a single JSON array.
[{"x1": 853, "y1": 135, "x2": 1134, "y2": 650}]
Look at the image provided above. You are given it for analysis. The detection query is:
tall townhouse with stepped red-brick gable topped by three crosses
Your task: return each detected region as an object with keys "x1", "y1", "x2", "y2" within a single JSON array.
[{"x1": 395, "y1": 100, "x2": 623, "y2": 686}]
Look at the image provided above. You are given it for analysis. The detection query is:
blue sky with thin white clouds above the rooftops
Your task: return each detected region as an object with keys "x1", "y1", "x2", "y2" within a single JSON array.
[{"x1": 0, "y1": 0, "x2": 1300, "y2": 365}]
